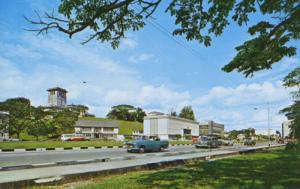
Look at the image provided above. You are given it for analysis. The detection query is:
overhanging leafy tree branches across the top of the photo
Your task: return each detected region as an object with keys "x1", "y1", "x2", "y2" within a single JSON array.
[{"x1": 25, "y1": 0, "x2": 300, "y2": 77}]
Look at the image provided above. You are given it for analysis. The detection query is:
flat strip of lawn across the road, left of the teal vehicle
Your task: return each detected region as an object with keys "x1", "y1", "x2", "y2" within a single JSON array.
[{"x1": 0, "y1": 140, "x2": 123, "y2": 149}]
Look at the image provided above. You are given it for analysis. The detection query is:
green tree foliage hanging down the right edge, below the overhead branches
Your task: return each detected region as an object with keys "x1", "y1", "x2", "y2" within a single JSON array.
[{"x1": 280, "y1": 67, "x2": 300, "y2": 139}]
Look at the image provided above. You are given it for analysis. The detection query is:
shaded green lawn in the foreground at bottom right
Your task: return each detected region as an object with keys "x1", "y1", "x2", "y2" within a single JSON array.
[{"x1": 64, "y1": 150, "x2": 300, "y2": 189}]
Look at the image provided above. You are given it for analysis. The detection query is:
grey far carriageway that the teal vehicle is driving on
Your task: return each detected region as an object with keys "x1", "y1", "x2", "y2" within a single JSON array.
[{"x1": 0, "y1": 144, "x2": 274, "y2": 167}]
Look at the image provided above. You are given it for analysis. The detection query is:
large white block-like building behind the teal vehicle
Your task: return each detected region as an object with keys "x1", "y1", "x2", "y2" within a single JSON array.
[{"x1": 144, "y1": 114, "x2": 199, "y2": 140}]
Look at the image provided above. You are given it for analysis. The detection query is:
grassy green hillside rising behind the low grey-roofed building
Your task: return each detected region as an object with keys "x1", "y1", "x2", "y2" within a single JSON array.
[{"x1": 79, "y1": 117, "x2": 143, "y2": 135}]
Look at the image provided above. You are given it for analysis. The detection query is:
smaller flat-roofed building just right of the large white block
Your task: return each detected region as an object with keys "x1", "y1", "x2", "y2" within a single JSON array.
[{"x1": 199, "y1": 121, "x2": 224, "y2": 137}]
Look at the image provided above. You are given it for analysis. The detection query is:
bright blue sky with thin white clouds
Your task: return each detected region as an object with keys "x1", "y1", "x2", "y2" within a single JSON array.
[{"x1": 0, "y1": 0, "x2": 300, "y2": 133}]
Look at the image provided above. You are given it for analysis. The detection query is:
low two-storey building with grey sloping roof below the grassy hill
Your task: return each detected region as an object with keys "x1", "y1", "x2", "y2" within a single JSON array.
[{"x1": 74, "y1": 120, "x2": 119, "y2": 138}]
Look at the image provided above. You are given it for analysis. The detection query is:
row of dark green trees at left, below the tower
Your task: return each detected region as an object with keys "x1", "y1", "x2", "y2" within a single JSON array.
[{"x1": 0, "y1": 97, "x2": 82, "y2": 140}]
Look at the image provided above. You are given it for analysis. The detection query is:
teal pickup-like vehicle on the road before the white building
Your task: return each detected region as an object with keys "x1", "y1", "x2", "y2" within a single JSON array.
[{"x1": 126, "y1": 139, "x2": 169, "y2": 153}]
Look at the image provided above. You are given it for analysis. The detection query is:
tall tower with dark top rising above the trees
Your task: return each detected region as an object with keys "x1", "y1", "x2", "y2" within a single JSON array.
[{"x1": 47, "y1": 87, "x2": 68, "y2": 107}]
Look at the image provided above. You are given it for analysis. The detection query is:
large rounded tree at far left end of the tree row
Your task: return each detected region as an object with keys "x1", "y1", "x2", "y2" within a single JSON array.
[{"x1": 0, "y1": 97, "x2": 32, "y2": 138}]
